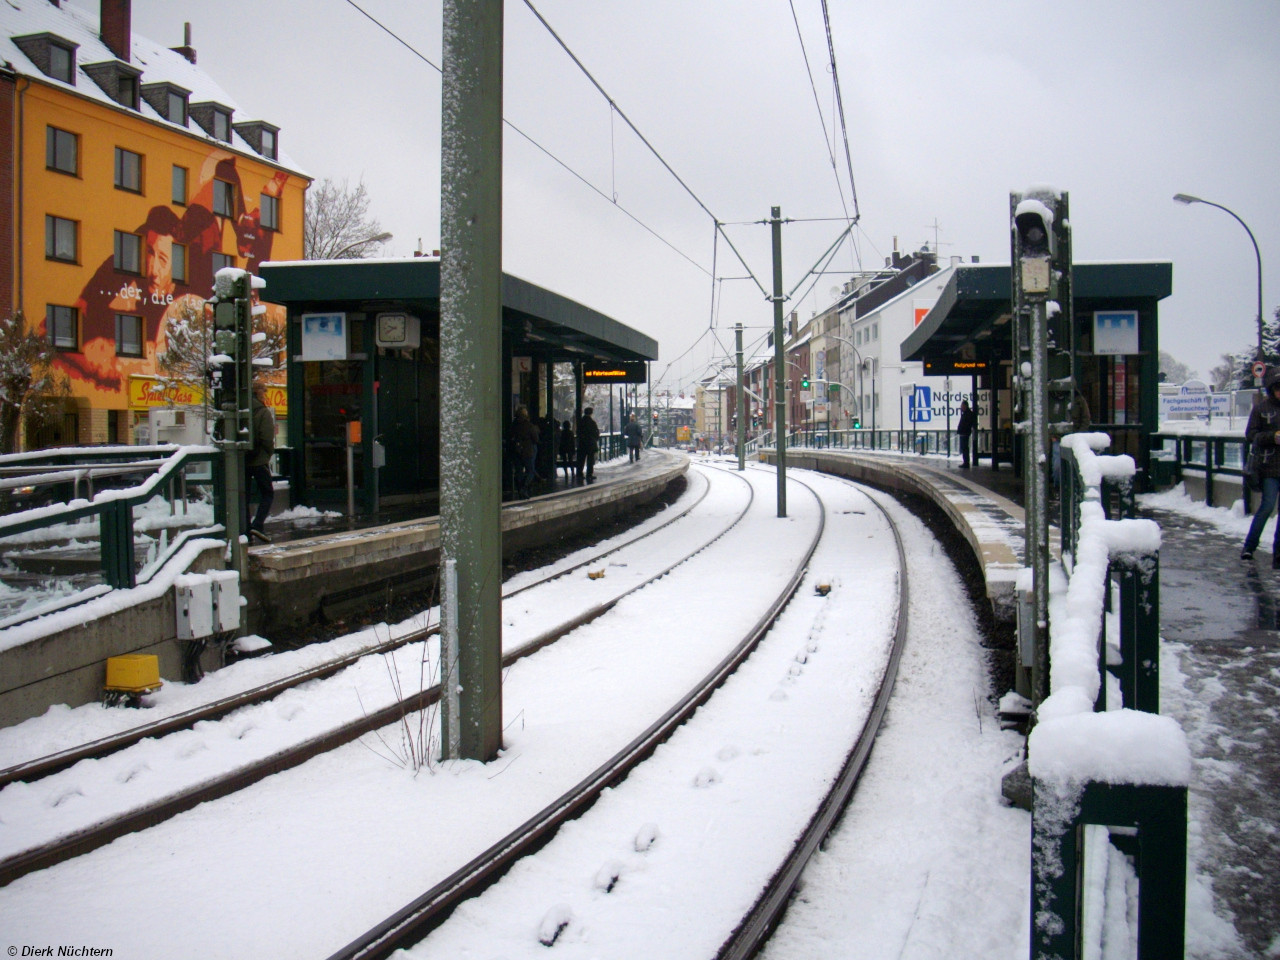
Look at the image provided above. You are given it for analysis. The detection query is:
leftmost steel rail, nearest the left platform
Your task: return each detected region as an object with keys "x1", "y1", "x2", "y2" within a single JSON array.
[{"x1": 0, "y1": 465, "x2": 710, "y2": 788}]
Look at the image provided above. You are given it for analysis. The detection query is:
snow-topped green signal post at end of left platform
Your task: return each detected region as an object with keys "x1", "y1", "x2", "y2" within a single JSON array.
[{"x1": 210, "y1": 268, "x2": 256, "y2": 577}]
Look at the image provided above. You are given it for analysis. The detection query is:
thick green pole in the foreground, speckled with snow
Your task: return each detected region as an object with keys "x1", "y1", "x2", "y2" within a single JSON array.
[{"x1": 440, "y1": 0, "x2": 503, "y2": 760}]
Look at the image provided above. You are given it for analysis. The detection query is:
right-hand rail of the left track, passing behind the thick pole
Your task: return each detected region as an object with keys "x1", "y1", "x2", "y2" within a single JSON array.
[{"x1": 0, "y1": 477, "x2": 755, "y2": 887}]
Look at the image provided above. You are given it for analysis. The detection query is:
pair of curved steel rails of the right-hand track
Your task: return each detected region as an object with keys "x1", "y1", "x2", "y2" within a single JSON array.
[{"x1": 329, "y1": 467, "x2": 909, "y2": 960}]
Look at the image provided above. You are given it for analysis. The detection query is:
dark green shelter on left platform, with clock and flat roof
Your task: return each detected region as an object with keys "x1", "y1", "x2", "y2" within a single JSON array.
[{"x1": 260, "y1": 257, "x2": 658, "y2": 513}]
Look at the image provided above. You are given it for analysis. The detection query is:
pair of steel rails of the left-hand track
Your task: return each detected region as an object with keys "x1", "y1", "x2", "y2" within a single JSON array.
[{"x1": 0, "y1": 463, "x2": 754, "y2": 887}]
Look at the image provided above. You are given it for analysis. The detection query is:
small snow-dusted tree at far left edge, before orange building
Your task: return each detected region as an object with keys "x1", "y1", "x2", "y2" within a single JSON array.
[{"x1": 0, "y1": 314, "x2": 70, "y2": 453}]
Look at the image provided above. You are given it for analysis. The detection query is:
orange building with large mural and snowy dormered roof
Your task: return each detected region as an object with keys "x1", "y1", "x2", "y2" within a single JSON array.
[{"x1": 0, "y1": 0, "x2": 310, "y2": 448}]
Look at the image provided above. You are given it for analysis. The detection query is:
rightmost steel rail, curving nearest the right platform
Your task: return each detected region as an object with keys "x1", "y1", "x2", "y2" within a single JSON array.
[{"x1": 716, "y1": 477, "x2": 910, "y2": 960}]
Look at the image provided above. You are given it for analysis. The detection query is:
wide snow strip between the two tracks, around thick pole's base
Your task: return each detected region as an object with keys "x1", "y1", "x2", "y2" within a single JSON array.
[{"x1": 0, "y1": 471, "x2": 817, "y2": 957}]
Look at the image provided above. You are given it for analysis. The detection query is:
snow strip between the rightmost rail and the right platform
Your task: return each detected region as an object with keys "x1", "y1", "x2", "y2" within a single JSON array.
[{"x1": 763, "y1": 483, "x2": 1030, "y2": 960}]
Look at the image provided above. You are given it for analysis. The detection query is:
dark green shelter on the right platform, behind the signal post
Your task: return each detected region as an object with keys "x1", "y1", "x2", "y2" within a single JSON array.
[{"x1": 901, "y1": 261, "x2": 1174, "y2": 485}]
